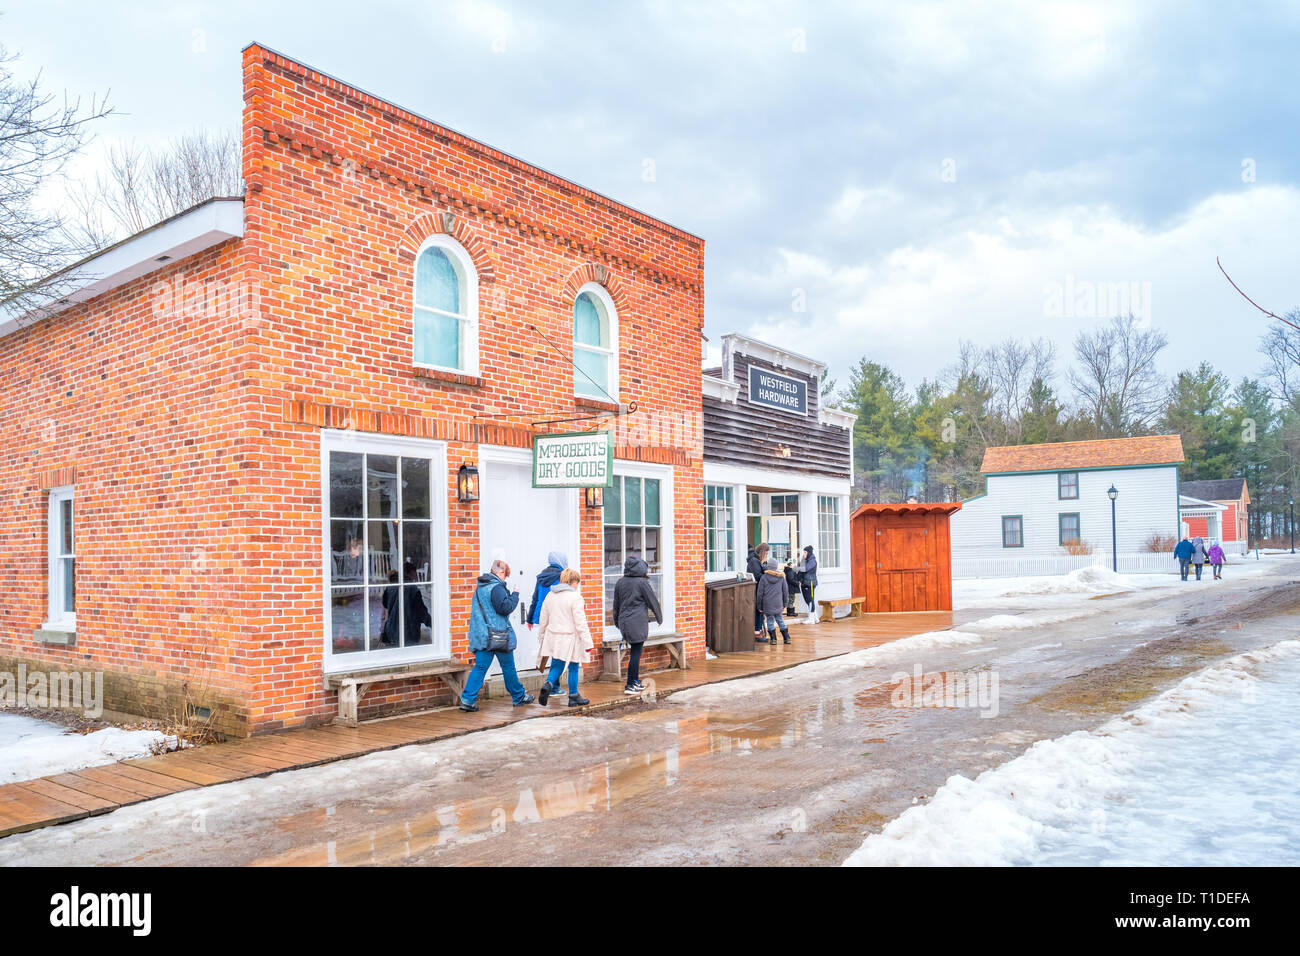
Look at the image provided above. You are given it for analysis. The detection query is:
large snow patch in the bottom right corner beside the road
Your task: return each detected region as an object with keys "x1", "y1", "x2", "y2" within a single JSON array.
[{"x1": 845, "y1": 640, "x2": 1300, "y2": 866}]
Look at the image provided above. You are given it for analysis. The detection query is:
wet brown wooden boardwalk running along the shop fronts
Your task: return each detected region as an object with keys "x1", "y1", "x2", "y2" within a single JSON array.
[{"x1": 0, "y1": 611, "x2": 967, "y2": 838}]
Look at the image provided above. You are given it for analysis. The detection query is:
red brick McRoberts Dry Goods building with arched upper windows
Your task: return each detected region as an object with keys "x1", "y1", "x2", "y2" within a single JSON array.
[{"x1": 0, "y1": 44, "x2": 705, "y2": 734}]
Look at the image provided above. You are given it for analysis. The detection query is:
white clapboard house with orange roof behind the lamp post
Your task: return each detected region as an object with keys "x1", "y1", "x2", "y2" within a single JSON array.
[{"x1": 950, "y1": 434, "x2": 1183, "y2": 578}]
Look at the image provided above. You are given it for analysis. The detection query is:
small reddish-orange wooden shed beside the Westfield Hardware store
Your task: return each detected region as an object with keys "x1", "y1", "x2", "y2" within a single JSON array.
[{"x1": 849, "y1": 501, "x2": 961, "y2": 614}]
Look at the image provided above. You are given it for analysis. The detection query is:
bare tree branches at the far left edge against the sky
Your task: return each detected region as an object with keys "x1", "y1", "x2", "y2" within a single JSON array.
[{"x1": 0, "y1": 46, "x2": 113, "y2": 316}]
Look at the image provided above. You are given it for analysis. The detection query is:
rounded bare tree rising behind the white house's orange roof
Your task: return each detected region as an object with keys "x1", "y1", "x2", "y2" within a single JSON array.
[{"x1": 1069, "y1": 313, "x2": 1169, "y2": 438}]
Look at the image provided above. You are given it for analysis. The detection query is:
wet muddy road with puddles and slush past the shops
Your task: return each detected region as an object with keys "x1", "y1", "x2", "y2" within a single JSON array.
[{"x1": 0, "y1": 563, "x2": 1300, "y2": 865}]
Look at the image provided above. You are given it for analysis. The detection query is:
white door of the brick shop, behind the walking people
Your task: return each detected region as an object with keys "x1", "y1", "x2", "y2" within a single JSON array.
[{"x1": 478, "y1": 458, "x2": 577, "y2": 674}]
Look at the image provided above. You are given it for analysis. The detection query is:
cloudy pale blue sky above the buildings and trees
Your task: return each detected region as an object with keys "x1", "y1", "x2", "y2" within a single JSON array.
[{"x1": 0, "y1": 0, "x2": 1300, "y2": 395}]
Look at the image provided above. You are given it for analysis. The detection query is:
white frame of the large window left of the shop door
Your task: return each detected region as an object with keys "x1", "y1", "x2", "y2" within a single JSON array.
[{"x1": 319, "y1": 429, "x2": 451, "y2": 674}]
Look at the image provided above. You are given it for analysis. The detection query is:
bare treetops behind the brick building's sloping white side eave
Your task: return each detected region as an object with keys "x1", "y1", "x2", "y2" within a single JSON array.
[{"x1": 70, "y1": 130, "x2": 243, "y2": 248}]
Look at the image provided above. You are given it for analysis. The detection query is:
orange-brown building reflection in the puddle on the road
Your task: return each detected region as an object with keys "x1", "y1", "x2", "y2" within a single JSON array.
[{"x1": 254, "y1": 685, "x2": 898, "y2": 866}]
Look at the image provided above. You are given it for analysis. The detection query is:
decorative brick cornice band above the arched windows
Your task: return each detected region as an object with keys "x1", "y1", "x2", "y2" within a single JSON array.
[{"x1": 254, "y1": 124, "x2": 701, "y2": 293}]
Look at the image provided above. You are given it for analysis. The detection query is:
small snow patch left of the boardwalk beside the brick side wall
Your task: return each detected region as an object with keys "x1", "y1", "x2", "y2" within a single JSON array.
[{"x1": 0, "y1": 713, "x2": 164, "y2": 784}]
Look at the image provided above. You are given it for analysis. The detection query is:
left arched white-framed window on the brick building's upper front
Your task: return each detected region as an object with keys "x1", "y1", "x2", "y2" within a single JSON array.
[{"x1": 413, "y1": 234, "x2": 478, "y2": 375}]
